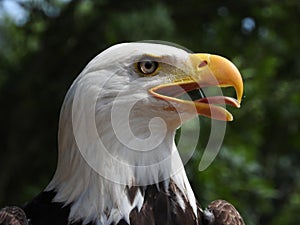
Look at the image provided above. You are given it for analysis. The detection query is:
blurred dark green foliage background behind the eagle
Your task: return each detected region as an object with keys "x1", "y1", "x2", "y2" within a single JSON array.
[{"x1": 0, "y1": 0, "x2": 300, "y2": 225}]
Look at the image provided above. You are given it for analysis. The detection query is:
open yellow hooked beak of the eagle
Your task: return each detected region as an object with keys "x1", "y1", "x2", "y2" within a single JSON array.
[{"x1": 149, "y1": 54, "x2": 243, "y2": 121}]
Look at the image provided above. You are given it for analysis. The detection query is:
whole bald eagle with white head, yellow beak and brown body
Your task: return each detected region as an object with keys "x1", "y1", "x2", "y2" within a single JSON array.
[{"x1": 0, "y1": 43, "x2": 244, "y2": 225}]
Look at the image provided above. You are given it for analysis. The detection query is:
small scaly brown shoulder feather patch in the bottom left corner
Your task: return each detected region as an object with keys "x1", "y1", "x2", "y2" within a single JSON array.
[{"x1": 0, "y1": 206, "x2": 28, "y2": 225}]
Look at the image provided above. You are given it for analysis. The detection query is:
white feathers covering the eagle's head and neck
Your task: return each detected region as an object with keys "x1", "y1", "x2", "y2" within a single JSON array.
[{"x1": 46, "y1": 43, "x2": 196, "y2": 224}]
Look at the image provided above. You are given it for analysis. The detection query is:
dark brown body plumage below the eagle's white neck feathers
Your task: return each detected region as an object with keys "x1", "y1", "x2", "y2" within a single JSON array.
[{"x1": 0, "y1": 190, "x2": 245, "y2": 225}]
